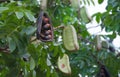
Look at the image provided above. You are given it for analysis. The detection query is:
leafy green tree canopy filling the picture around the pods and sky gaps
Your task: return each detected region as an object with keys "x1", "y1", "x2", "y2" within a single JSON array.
[{"x1": 0, "y1": 0, "x2": 120, "y2": 77}]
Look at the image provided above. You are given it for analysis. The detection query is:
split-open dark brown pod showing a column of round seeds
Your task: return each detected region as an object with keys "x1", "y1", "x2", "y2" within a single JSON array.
[{"x1": 36, "y1": 11, "x2": 54, "y2": 42}]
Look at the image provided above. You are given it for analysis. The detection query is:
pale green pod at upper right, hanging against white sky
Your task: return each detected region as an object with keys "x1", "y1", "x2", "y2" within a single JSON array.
[{"x1": 80, "y1": 7, "x2": 91, "y2": 23}]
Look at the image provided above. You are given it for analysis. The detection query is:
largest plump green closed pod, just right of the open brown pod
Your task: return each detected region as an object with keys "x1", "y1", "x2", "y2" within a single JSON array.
[{"x1": 63, "y1": 25, "x2": 79, "y2": 51}]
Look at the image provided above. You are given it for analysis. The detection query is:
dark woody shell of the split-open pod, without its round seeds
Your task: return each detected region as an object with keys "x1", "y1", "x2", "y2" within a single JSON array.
[{"x1": 36, "y1": 11, "x2": 54, "y2": 42}]
